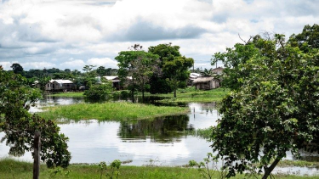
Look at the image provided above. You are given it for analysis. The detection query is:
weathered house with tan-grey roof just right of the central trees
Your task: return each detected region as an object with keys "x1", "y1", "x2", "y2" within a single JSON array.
[{"x1": 193, "y1": 77, "x2": 220, "y2": 90}]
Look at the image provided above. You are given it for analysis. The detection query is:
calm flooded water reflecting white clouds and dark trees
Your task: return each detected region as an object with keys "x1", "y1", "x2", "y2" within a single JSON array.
[{"x1": 0, "y1": 97, "x2": 319, "y2": 175}]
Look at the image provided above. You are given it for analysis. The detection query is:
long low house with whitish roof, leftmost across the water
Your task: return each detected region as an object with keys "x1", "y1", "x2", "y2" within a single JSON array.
[{"x1": 45, "y1": 80, "x2": 76, "y2": 91}]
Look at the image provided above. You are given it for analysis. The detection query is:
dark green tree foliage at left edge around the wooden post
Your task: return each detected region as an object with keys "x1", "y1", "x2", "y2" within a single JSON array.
[{"x1": 0, "y1": 70, "x2": 71, "y2": 167}]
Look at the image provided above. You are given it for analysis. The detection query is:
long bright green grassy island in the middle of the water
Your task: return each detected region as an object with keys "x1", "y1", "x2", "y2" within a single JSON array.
[{"x1": 38, "y1": 102, "x2": 189, "y2": 121}]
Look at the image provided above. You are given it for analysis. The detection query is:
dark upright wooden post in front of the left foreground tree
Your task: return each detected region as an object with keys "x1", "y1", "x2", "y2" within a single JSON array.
[{"x1": 33, "y1": 131, "x2": 41, "y2": 179}]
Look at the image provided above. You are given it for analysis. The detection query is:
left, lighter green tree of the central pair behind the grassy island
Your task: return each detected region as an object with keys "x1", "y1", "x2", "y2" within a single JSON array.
[{"x1": 115, "y1": 51, "x2": 158, "y2": 101}]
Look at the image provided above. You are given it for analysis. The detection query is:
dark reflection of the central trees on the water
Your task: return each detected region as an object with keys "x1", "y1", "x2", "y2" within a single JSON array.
[{"x1": 118, "y1": 115, "x2": 189, "y2": 143}]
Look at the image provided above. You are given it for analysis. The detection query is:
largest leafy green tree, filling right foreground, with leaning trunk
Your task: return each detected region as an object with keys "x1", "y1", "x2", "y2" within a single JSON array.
[{"x1": 212, "y1": 29, "x2": 319, "y2": 179}]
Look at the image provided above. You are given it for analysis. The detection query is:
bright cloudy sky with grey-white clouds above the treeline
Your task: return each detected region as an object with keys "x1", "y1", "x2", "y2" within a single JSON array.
[{"x1": 0, "y1": 0, "x2": 319, "y2": 70}]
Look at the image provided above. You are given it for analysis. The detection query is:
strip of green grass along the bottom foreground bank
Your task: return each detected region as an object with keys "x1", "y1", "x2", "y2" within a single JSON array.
[{"x1": 0, "y1": 159, "x2": 318, "y2": 179}]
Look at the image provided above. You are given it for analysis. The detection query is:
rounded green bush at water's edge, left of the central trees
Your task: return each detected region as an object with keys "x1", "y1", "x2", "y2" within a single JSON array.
[{"x1": 83, "y1": 82, "x2": 112, "y2": 101}]
